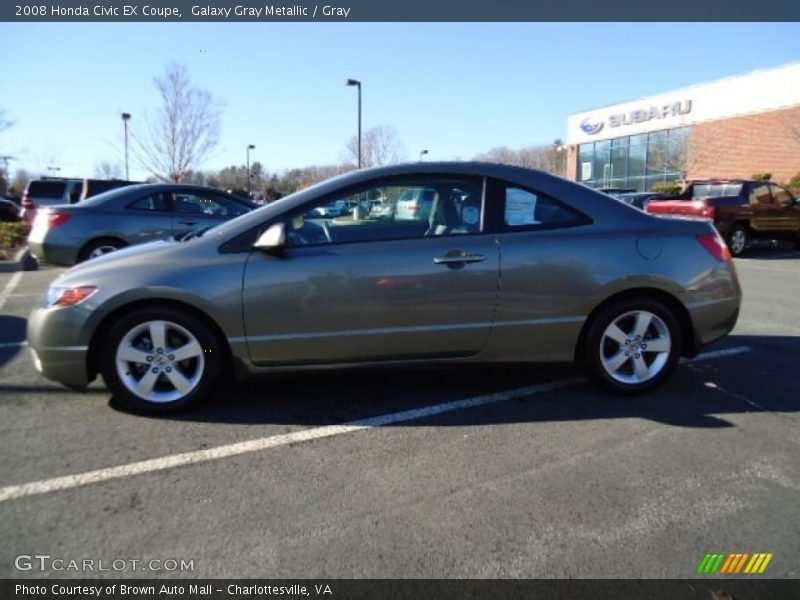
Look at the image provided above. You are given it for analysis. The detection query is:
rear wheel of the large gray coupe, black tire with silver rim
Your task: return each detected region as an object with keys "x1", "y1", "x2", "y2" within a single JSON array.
[{"x1": 583, "y1": 298, "x2": 682, "y2": 394}]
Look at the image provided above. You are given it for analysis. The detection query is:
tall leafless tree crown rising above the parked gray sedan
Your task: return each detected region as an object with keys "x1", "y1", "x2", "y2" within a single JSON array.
[{"x1": 132, "y1": 63, "x2": 221, "y2": 183}]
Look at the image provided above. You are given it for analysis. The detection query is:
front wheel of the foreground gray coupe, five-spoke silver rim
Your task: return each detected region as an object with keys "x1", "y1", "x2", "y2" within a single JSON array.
[{"x1": 100, "y1": 308, "x2": 221, "y2": 414}]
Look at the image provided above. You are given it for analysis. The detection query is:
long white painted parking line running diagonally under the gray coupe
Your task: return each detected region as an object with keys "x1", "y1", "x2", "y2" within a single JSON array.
[{"x1": 0, "y1": 346, "x2": 750, "y2": 502}]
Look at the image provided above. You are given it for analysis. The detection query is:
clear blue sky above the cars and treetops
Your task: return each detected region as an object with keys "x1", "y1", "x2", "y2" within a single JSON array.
[{"x1": 0, "y1": 23, "x2": 800, "y2": 178}]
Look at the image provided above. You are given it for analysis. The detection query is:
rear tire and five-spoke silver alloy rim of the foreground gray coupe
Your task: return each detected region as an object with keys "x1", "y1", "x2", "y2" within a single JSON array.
[{"x1": 581, "y1": 298, "x2": 683, "y2": 395}]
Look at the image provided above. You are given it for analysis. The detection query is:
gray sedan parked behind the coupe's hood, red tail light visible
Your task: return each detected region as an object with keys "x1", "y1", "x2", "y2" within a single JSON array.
[{"x1": 28, "y1": 183, "x2": 255, "y2": 265}]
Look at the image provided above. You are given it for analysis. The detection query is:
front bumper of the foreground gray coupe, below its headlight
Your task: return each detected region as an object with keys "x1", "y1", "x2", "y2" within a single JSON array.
[{"x1": 28, "y1": 307, "x2": 90, "y2": 388}]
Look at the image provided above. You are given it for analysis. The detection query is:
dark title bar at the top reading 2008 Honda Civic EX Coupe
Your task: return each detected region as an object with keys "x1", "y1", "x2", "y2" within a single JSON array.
[{"x1": 0, "y1": 0, "x2": 800, "y2": 22}]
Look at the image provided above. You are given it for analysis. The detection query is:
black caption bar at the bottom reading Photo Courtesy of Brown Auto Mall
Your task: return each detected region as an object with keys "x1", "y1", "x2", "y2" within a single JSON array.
[{"x1": 0, "y1": 576, "x2": 800, "y2": 600}]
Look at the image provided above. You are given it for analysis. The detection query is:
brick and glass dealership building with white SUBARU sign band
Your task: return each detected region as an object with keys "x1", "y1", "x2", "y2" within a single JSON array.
[{"x1": 567, "y1": 63, "x2": 800, "y2": 191}]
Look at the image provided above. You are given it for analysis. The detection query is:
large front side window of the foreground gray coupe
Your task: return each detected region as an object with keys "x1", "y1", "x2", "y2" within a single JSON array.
[{"x1": 285, "y1": 178, "x2": 483, "y2": 246}]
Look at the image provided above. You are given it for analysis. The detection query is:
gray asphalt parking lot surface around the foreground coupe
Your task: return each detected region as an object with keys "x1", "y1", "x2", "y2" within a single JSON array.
[{"x1": 0, "y1": 249, "x2": 800, "y2": 578}]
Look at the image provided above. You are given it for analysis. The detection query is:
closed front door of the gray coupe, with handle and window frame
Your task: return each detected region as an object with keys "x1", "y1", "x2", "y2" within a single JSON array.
[{"x1": 242, "y1": 177, "x2": 499, "y2": 365}]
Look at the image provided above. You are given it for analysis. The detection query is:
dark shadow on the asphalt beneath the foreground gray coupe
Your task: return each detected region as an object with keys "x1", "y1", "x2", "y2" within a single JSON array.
[{"x1": 111, "y1": 336, "x2": 800, "y2": 429}]
